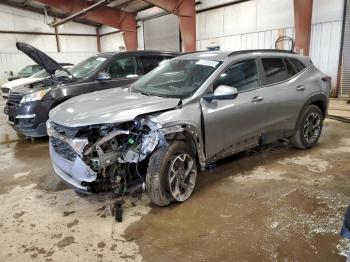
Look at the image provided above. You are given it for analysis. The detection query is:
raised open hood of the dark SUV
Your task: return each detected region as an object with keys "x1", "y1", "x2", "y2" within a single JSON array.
[{"x1": 16, "y1": 42, "x2": 65, "y2": 76}]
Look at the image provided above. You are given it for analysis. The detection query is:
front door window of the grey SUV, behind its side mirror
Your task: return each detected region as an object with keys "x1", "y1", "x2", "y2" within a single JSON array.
[{"x1": 214, "y1": 59, "x2": 259, "y2": 92}]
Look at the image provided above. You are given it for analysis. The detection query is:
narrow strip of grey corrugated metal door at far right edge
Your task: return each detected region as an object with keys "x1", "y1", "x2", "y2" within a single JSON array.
[{"x1": 340, "y1": 0, "x2": 350, "y2": 96}]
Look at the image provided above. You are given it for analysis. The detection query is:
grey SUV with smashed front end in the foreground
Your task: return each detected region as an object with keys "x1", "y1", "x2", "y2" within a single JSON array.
[{"x1": 47, "y1": 50, "x2": 330, "y2": 206}]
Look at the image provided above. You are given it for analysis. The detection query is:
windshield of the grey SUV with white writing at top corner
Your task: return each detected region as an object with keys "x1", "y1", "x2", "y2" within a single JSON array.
[{"x1": 132, "y1": 60, "x2": 221, "y2": 98}]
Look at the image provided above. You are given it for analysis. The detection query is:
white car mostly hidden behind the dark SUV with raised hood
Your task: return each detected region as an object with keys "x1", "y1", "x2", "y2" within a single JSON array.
[{"x1": 1, "y1": 65, "x2": 73, "y2": 99}]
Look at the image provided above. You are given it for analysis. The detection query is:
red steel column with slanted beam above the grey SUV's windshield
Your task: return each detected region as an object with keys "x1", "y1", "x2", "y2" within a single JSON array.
[{"x1": 145, "y1": 0, "x2": 196, "y2": 52}]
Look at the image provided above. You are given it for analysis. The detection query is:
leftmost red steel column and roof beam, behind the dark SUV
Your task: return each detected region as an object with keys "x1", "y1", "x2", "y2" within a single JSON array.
[{"x1": 37, "y1": 0, "x2": 137, "y2": 50}]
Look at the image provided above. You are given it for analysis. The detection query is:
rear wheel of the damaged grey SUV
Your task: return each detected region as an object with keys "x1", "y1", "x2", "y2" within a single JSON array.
[{"x1": 291, "y1": 105, "x2": 323, "y2": 149}]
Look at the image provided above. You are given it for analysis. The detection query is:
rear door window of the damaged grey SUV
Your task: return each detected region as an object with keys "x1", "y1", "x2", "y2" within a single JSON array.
[{"x1": 261, "y1": 58, "x2": 289, "y2": 85}]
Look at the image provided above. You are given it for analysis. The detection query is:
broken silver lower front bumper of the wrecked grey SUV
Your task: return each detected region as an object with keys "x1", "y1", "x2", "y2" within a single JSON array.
[{"x1": 50, "y1": 143, "x2": 97, "y2": 193}]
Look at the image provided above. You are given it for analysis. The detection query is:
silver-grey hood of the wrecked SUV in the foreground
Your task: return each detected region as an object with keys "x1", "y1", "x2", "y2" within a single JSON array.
[{"x1": 49, "y1": 88, "x2": 180, "y2": 127}]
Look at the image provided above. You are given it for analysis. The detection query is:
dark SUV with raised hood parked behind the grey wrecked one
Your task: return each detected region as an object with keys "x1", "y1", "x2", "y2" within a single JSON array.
[{"x1": 4, "y1": 43, "x2": 179, "y2": 137}]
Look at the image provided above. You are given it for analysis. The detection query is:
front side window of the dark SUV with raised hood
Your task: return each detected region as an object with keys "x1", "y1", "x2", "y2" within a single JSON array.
[{"x1": 108, "y1": 57, "x2": 138, "y2": 78}]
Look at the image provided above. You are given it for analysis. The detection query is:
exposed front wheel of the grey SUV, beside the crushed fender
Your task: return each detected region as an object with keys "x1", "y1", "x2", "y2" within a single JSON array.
[{"x1": 146, "y1": 141, "x2": 197, "y2": 206}]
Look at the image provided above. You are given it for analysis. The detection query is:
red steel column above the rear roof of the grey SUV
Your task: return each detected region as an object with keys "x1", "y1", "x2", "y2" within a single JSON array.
[{"x1": 294, "y1": 0, "x2": 313, "y2": 56}]
